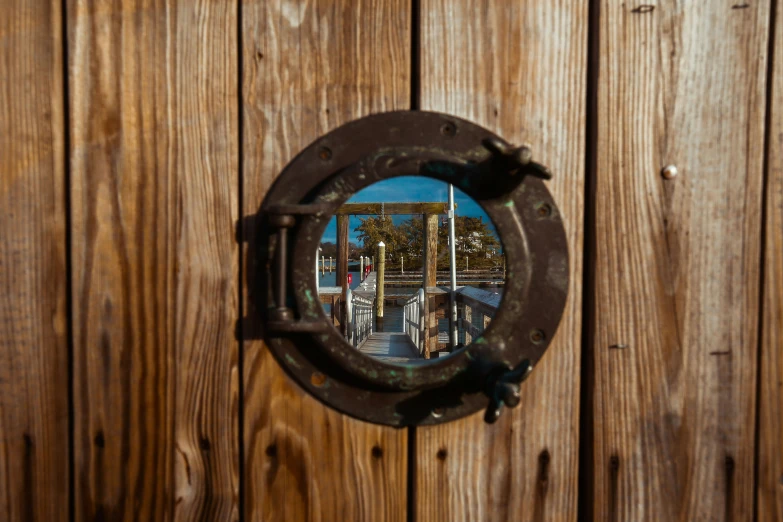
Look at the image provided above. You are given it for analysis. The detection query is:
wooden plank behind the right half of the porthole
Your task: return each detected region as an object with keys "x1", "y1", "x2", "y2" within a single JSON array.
[{"x1": 416, "y1": 0, "x2": 588, "y2": 522}]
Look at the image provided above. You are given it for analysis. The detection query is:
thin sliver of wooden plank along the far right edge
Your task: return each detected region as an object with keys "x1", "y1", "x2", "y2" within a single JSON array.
[{"x1": 757, "y1": 2, "x2": 783, "y2": 522}]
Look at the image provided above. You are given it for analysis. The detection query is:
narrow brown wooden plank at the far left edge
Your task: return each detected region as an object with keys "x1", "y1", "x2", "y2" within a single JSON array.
[{"x1": 0, "y1": 0, "x2": 70, "y2": 522}]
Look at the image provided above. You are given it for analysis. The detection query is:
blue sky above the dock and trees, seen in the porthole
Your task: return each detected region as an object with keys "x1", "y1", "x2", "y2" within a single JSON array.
[{"x1": 321, "y1": 176, "x2": 494, "y2": 244}]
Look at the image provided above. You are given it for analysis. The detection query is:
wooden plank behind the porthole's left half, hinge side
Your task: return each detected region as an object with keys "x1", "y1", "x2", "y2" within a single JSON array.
[{"x1": 241, "y1": 0, "x2": 411, "y2": 522}]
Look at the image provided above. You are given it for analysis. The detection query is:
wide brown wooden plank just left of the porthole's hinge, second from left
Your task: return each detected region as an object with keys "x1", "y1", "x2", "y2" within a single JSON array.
[{"x1": 67, "y1": 0, "x2": 239, "y2": 521}]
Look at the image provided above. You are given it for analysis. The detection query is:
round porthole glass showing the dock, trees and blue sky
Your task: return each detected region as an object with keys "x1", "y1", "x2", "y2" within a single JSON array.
[{"x1": 315, "y1": 176, "x2": 505, "y2": 364}]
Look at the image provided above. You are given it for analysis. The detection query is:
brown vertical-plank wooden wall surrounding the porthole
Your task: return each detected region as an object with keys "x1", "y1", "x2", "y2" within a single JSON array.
[{"x1": 0, "y1": 0, "x2": 783, "y2": 522}]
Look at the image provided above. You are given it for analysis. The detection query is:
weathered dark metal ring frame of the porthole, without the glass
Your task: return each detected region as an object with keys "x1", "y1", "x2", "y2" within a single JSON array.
[{"x1": 251, "y1": 111, "x2": 568, "y2": 426}]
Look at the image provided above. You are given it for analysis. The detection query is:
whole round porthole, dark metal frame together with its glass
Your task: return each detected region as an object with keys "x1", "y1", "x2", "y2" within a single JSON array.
[{"x1": 248, "y1": 111, "x2": 568, "y2": 426}]
